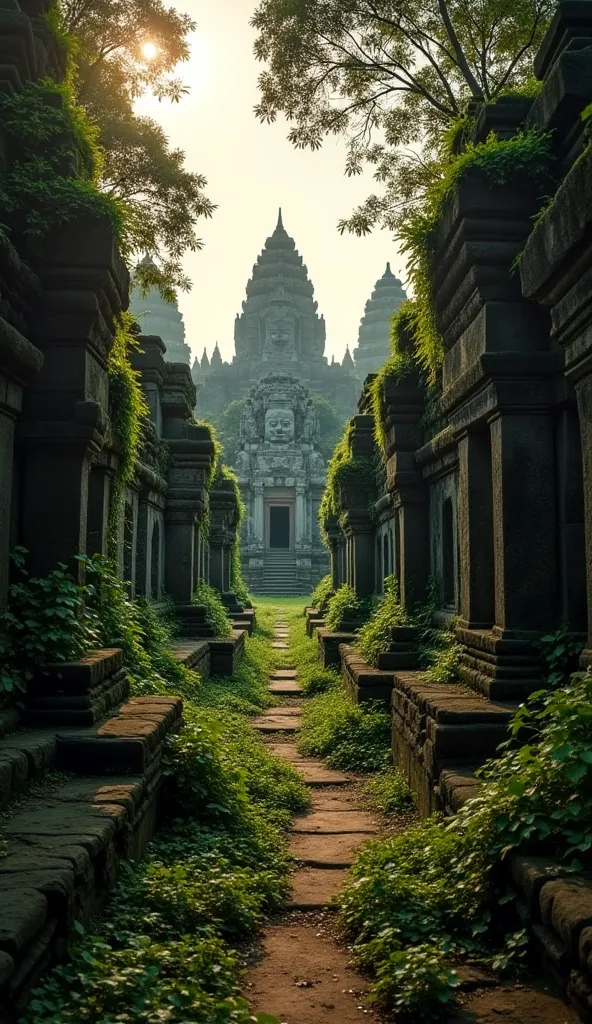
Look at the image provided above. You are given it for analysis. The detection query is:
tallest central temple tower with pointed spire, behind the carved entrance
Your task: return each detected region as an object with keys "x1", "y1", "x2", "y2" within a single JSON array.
[{"x1": 194, "y1": 211, "x2": 358, "y2": 420}]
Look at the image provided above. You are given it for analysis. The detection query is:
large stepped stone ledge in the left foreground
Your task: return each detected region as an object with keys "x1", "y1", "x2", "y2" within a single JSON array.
[{"x1": 0, "y1": 696, "x2": 181, "y2": 1021}]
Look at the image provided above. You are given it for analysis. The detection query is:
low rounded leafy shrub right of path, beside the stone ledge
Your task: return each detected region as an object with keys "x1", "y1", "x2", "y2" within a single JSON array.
[{"x1": 298, "y1": 685, "x2": 390, "y2": 772}]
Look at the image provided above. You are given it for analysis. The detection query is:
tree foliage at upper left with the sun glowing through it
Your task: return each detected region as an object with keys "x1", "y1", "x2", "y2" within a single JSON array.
[{"x1": 58, "y1": 0, "x2": 214, "y2": 299}]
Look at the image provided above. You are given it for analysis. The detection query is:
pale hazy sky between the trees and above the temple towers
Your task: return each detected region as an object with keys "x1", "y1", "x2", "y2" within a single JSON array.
[{"x1": 138, "y1": 0, "x2": 404, "y2": 359}]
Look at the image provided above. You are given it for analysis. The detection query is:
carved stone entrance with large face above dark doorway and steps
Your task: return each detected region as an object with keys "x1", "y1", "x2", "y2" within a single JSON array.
[{"x1": 237, "y1": 374, "x2": 328, "y2": 594}]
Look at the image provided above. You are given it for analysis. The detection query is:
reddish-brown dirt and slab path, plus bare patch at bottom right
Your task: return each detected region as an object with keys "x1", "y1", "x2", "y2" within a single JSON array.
[{"x1": 240, "y1": 620, "x2": 577, "y2": 1024}]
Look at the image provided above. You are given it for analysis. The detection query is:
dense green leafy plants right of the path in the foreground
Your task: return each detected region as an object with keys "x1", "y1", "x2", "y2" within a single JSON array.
[{"x1": 339, "y1": 674, "x2": 592, "y2": 1019}]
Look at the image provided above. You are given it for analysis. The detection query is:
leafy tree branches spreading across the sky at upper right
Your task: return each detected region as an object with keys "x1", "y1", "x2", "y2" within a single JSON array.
[{"x1": 252, "y1": 0, "x2": 555, "y2": 234}]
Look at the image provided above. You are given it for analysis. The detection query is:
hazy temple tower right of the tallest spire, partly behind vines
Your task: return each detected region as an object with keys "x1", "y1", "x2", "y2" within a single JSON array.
[{"x1": 353, "y1": 263, "x2": 407, "y2": 380}]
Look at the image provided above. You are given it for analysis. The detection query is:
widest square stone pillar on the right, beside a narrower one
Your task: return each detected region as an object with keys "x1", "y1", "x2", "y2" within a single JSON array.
[{"x1": 491, "y1": 413, "x2": 558, "y2": 636}]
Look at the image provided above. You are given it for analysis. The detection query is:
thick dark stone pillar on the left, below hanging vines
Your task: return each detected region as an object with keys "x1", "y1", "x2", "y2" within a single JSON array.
[{"x1": 19, "y1": 219, "x2": 129, "y2": 575}]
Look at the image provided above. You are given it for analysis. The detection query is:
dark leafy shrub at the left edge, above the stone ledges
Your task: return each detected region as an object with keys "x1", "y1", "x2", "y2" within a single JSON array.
[{"x1": 0, "y1": 548, "x2": 99, "y2": 694}]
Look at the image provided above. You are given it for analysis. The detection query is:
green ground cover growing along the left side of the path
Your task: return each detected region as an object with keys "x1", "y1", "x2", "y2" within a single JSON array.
[{"x1": 22, "y1": 609, "x2": 308, "y2": 1024}]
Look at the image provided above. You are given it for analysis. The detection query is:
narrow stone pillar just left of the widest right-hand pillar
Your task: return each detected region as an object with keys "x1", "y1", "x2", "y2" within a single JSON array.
[{"x1": 458, "y1": 430, "x2": 496, "y2": 630}]
